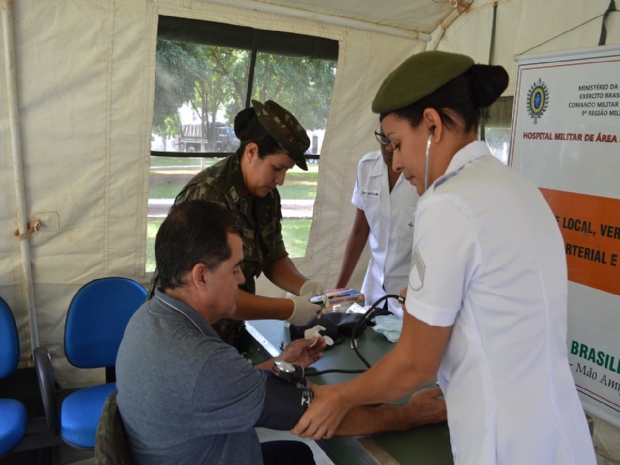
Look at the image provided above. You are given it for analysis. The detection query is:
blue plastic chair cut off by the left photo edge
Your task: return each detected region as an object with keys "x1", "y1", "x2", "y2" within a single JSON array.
[{"x1": 0, "y1": 297, "x2": 28, "y2": 456}]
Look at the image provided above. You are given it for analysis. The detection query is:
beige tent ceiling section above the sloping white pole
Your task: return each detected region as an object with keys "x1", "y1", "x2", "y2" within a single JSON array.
[{"x1": 257, "y1": 0, "x2": 453, "y2": 34}]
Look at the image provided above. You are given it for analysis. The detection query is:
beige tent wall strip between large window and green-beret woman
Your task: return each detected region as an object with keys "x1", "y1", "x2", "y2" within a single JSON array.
[{"x1": 274, "y1": 30, "x2": 425, "y2": 296}]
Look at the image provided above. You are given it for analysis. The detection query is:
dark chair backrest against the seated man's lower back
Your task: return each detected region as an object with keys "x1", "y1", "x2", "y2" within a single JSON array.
[{"x1": 95, "y1": 391, "x2": 134, "y2": 465}]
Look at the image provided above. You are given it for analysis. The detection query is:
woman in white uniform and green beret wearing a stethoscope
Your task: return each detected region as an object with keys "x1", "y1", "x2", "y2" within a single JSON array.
[{"x1": 293, "y1": 51, "x2": 596, "y2": 465}]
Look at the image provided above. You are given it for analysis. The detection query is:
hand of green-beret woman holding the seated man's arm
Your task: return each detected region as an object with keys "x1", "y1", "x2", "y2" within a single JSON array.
[{"x1": 291, "y1": 384, "x2": 351, "y2": 441}]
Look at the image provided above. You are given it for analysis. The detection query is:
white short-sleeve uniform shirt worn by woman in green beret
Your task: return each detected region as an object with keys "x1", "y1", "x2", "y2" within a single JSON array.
[{"x1": 406, "y1": 142, "x2": 596, "y2": 465}]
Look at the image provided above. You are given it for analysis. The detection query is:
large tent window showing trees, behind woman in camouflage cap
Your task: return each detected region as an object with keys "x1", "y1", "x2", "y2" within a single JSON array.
[{"x1": 146, "y1": 16, "x2": 338, "y2": 272}]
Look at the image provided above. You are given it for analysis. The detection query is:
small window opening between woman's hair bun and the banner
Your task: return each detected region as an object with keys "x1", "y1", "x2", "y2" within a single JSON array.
[{"x1": 480, "y1": 97, "x2": 514, "y2": 164}]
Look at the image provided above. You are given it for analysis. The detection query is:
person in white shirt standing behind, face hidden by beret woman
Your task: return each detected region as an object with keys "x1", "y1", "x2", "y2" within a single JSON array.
[{"x1": 336, "y1": 134, "x2": 419, "y2": 320}]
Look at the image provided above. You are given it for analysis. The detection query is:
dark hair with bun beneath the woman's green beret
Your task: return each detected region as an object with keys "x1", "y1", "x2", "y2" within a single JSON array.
[{"x1": 380, "y1": 65, "x2": 508, "y2": 133}]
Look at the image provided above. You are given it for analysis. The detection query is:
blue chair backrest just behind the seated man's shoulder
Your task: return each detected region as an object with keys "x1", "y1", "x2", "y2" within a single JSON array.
[{"x1": 65, "y1": 278, "x2": 146, "y2": 368}]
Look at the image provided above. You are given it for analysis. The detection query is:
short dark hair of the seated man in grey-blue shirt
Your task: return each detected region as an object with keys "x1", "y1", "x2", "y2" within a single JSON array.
[{"x1": 155, "y1": 200, "x2": 243, "y2": 290}]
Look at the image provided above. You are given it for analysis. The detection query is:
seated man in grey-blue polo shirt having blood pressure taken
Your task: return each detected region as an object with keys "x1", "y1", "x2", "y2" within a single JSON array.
[{"x1": 116, "y1": 200, "x2": 445, "y2": 465}]
